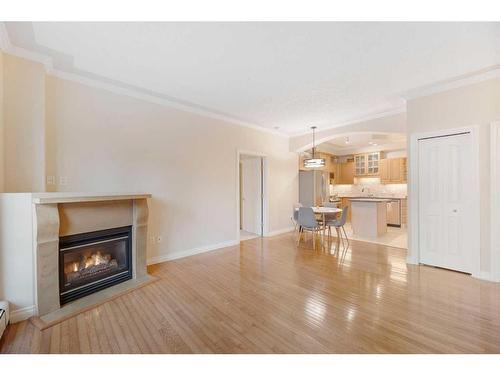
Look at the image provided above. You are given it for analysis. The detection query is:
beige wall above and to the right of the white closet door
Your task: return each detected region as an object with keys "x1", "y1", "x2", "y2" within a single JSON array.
[{"x1": 407, "y1": 78, "x2": 500, "y2": 272}]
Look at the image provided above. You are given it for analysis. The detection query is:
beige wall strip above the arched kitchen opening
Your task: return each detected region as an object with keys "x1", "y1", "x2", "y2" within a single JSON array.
[{"x1": 290, "y1": 113, "x2": 406, "y2": 151}]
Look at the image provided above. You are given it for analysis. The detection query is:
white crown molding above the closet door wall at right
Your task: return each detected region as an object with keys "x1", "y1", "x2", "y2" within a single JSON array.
[{"x1": 401, "y1": 64, "x2": 500, "y2": 101}]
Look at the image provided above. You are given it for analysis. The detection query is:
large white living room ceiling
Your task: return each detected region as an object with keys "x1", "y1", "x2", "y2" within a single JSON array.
[{"x1": 6, "y1": 22, "x2": 500, "y2": 134}]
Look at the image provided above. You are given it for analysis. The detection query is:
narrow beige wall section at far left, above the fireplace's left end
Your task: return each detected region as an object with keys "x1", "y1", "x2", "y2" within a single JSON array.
[{"x1": 3, "y1": 54, "x2": 45, "y2": 192}]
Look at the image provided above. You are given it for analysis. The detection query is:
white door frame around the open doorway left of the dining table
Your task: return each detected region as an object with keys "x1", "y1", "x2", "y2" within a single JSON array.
[{"x1": 236, "y1": 149, "x2": 269, "y2": 242}]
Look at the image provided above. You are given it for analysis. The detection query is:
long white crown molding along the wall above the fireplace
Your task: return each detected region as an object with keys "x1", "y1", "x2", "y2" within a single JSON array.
[{"x1": 0, "y1": 22, "x2": 289, "y2": 139}]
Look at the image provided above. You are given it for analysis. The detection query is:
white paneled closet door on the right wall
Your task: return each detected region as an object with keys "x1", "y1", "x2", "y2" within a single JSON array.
[{"x1": 418, "y1": 133, "x2": 472, "y2": 273}]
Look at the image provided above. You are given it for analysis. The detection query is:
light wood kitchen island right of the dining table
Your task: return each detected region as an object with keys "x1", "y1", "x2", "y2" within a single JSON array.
[{"x1": 350, "y1": 198, "x2": 388, "y2": 237}]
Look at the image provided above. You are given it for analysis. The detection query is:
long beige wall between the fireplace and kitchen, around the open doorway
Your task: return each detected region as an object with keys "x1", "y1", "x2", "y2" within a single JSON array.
[{"x1": 42, "y1": 76, "x2": 298, "y2": 259}]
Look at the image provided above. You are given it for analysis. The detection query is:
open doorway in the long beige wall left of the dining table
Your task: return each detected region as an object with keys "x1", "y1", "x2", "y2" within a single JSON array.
[{"x1": 239, "y1": 154, "x2": 264, "y2": 240}]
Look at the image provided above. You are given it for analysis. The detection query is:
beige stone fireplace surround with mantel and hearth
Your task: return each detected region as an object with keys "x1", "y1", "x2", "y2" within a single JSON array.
[{"x1": 33, "y1": 193, "x2": 154, "y2": 328}]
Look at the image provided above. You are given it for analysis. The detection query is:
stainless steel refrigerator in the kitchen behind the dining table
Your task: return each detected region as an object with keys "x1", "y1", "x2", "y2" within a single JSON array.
[{"x1": 299, "y1": 171, "x2": 330, "y2": 207}]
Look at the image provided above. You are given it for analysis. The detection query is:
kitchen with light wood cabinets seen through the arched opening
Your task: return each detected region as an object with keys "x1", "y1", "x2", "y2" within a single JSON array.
[{"x1": 299, "y1": 134, "x2": 408, "y2": 248}]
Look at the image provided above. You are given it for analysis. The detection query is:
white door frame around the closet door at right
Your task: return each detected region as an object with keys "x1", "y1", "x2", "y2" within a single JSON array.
[{"x1": 406, "y1": 125, "x2": 481, "y2": 278}]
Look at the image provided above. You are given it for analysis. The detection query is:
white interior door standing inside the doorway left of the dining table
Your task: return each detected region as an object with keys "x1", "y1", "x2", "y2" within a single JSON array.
[{"x1": 241, "y1": 157, "x2": 262, "y2": 235}]
